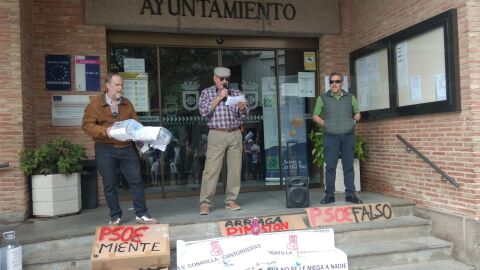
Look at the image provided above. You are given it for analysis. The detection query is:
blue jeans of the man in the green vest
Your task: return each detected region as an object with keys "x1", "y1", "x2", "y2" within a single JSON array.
[{"x1": 323, "y1": 133, "x2": 355, "y2": 195}]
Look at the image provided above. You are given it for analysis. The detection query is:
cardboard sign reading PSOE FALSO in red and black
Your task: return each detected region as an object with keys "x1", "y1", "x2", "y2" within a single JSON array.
[{"x1": 306, "y1": 203, "x2": 395, "y2": 227}]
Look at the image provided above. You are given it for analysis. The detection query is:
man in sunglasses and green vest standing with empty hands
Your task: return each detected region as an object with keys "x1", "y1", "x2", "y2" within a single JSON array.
[{"x1": 313, "y1": 72, "x2": 362, "y2": 204}]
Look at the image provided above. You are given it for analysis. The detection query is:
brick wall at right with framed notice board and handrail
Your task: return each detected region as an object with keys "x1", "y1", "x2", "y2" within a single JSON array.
[{"x1": 334, "y1": 0, "x2": 480, "y2": 217}]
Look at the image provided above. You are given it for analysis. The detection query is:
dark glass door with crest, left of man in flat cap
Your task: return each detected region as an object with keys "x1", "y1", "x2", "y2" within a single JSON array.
[{"x1": 159, "y1": 48, "x2": 217, "y2": 195}]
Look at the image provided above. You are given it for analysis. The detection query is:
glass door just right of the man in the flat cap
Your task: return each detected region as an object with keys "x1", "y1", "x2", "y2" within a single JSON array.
[{"x1": 221, "y1": 49, "x2": 279, "y2": 191}]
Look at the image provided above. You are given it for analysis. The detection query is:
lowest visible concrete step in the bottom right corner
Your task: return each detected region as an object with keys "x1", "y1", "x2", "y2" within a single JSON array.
[{"x1": 370, "y1": 259, "x2": 475, "y2": 270}]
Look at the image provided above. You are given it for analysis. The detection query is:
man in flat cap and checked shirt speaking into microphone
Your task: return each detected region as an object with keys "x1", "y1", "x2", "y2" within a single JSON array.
[{"x1": 199, "y1": 67, "x2": 249, "y2": 215}]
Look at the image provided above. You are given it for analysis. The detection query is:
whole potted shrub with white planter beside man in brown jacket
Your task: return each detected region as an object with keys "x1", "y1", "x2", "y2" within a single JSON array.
[{"x1": 20, "y1": 137, "x2": 87, "y2": 216}]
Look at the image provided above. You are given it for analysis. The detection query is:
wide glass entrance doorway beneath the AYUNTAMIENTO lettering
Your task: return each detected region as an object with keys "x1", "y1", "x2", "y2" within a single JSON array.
[{"x1": 108, "y1": 32, "x2": 319, "y2": 197}]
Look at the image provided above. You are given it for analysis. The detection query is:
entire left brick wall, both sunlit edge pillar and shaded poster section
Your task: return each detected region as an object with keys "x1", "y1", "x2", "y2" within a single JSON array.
[{"x1": 0, "y1": 0, "x2": 107, "y2": 222}]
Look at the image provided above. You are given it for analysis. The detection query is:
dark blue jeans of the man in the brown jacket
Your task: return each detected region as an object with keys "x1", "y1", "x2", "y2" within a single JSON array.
[{"x1": 95, "y1": 143, "x2": 147, "y2": 218}]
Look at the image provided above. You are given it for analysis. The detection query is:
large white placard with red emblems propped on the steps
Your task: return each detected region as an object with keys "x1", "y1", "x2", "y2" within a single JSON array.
[{"x1": 177, "y1": 229, "x2": 348, "y2": 270}]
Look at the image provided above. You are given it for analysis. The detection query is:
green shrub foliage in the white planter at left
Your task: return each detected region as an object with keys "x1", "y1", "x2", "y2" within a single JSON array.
[{"x1": 20, "y1": 137, "x2": 87, "y2": 175}]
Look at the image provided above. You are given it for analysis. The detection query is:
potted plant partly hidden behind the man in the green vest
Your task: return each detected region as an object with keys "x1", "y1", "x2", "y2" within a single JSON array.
[{"x1": 308, "y1": 130, "x2": 365, "y2": 192}]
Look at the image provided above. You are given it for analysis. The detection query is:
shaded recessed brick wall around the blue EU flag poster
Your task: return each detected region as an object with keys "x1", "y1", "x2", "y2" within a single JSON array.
[{"x1": 33, "y1": 0, "x2": 107, "y2": 207}]
